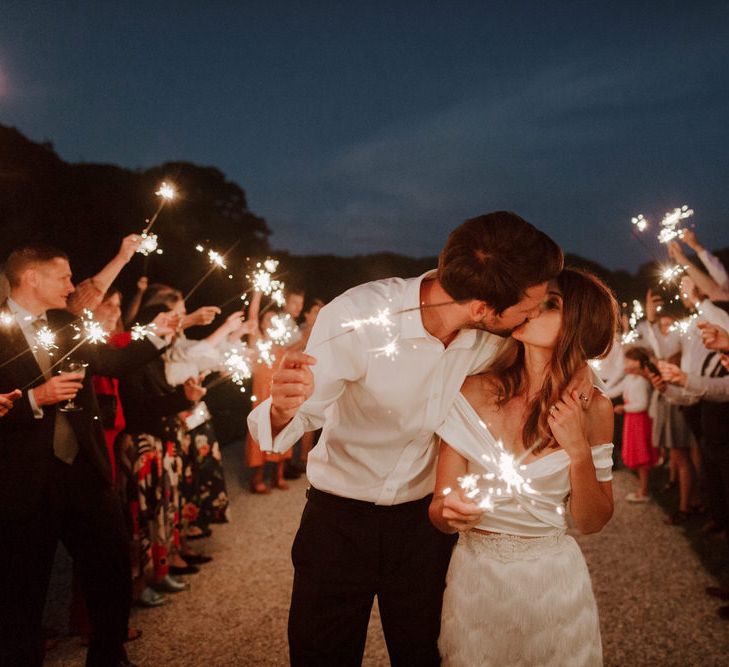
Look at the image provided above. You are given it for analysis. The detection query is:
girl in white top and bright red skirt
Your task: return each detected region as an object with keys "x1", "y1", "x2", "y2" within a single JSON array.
[{"x1": 615, "y1": 347, "x2": 658, "y2": 503}]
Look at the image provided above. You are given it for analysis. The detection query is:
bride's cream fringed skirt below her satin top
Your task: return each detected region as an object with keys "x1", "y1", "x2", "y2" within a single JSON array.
[{"x1": 438, "y1": 531, "x2": 602, "y2": 667}]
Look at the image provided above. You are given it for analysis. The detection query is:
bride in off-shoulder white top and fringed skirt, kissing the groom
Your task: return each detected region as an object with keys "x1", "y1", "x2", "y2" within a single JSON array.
[{"x1": 430, "y1": 269, "x2": 617, "y2": 667}]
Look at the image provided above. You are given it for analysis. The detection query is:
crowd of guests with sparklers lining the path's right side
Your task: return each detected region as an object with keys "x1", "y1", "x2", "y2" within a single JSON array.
[{"x1": 598, "y1": 230, "x2": 729, "y2": 620}]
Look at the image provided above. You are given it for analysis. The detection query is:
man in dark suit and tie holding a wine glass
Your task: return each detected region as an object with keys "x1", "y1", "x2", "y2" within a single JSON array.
[{"x1": 0, "y1": 245, "x2": 173, "y2": 667}]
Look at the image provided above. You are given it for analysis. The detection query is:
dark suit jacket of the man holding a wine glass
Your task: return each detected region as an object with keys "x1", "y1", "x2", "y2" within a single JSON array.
[{"x1": 0, "y1": 303, "x2": 161, "y2": 520}]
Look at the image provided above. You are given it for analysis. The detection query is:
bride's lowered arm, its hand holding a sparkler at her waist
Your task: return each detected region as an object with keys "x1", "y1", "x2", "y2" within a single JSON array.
[{"x1": 428, "y1": 440, "x2": 484, "y2": 533}]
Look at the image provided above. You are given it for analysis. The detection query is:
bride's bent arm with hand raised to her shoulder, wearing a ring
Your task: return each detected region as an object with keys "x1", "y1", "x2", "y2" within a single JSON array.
[{"x1": 549, "y1": 392, "x2": 613, "y2": 533}]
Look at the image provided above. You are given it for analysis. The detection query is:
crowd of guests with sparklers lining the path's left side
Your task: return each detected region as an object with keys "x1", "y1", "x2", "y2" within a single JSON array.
[{"x1": 0, "y1": 235, "x2": 323, "y2": 667}]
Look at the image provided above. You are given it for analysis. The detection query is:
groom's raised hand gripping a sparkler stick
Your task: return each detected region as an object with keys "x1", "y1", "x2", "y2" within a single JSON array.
[{"x1": 271, "y1": 352, "x2": 316, "y2": 436}]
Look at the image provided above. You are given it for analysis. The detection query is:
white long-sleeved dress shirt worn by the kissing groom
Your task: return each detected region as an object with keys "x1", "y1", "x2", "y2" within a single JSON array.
[{"x1": 248, "y1": 273, "x2": 503, "y2": 505}]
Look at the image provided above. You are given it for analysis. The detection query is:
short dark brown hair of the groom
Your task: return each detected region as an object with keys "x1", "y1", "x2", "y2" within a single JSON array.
[{"x1": 438, "y1": 211, "x2": 564, "y2": 314}]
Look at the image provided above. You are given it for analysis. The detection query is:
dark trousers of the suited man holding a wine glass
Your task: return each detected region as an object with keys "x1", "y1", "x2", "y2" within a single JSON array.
[{"x1": 0, "y1": 454, "x2": 131, "y2": 667}]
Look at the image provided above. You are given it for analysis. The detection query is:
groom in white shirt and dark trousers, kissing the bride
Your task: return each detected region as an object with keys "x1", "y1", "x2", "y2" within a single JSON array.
[{"x1": 248, "y1": 212, "x2": 563, "y2": 667}]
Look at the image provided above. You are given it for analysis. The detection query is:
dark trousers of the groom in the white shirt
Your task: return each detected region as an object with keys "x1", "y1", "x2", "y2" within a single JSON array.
[{"x1": 289, "y1": 489, "x2": 457, "y2": 667}]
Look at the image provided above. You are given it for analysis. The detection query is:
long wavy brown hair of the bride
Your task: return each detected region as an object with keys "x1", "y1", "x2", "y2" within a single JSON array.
[{"x1": 486, "y1": 268, "x2": 619, "y2": 452}]
